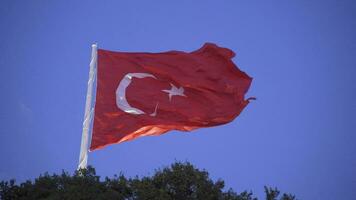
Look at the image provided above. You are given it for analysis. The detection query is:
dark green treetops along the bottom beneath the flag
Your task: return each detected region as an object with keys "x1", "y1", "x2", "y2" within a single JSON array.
[{"x1": 0, "y1": 162, "x2": 296, "y2": 200}]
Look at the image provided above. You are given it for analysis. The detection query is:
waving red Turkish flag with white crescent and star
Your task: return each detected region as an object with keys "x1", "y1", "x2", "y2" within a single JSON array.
[{"x1": 90, "y1": 43, "x2": 252, "y2": 151}]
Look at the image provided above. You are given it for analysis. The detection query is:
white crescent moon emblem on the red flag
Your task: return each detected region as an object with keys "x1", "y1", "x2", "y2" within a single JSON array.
[{"x1": 116, "y1": 73, "x2": 157, "y2": 115}]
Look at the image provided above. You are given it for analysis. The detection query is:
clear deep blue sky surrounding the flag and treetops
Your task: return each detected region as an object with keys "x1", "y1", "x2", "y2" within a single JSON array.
[{"x1": 0, "y1": 0, "x2": 356, "y2": 200}]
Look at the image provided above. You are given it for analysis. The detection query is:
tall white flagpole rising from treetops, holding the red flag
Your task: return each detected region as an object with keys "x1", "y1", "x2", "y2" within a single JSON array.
[{"x1": 78, "y1": 43, "x2": 98, "y2": 169}]
